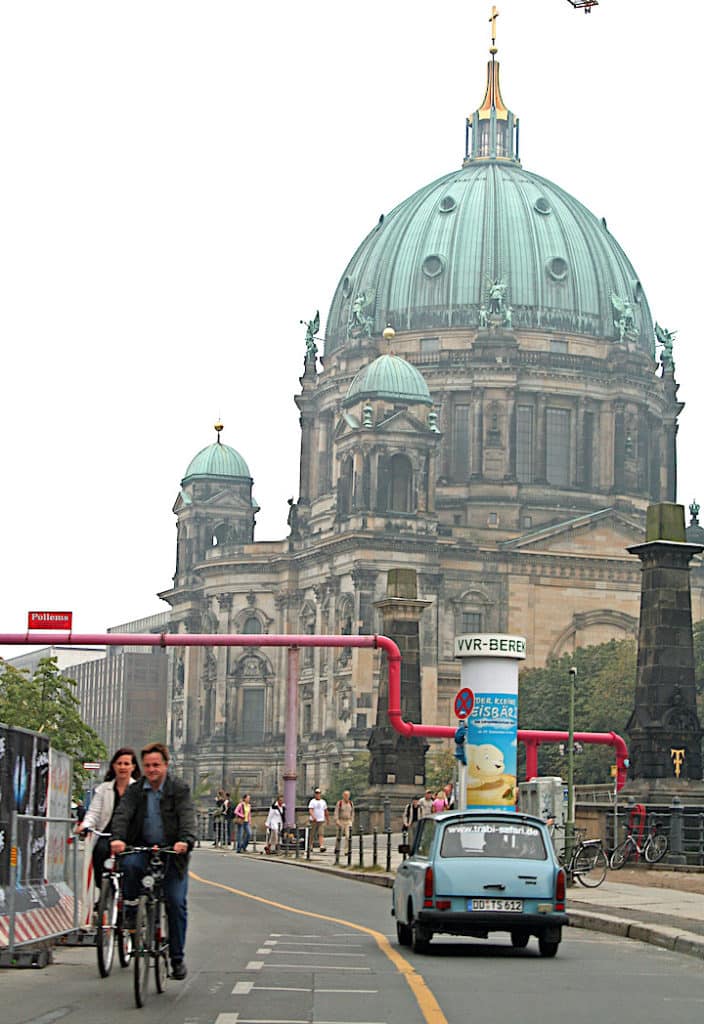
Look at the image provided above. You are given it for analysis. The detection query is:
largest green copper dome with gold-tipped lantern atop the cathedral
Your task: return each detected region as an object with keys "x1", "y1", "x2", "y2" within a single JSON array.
[{"x1": 325, "y1": 60, "x2": 654, "y2": 353}]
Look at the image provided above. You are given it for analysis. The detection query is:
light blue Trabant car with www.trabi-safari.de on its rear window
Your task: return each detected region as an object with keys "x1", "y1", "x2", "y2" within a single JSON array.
[{"x1": 391, "y1": 811, "x2": 568, "y2": 956}]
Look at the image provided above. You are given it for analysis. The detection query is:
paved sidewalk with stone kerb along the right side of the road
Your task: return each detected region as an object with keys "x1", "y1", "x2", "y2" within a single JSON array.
[{"x1": 232, "y1": 836, "x2": 704, "y2": 959}]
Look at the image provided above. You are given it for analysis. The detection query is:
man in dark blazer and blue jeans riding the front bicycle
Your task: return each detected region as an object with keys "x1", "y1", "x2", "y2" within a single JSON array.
[{"x1": 111, "y1": 743, "x2": 195, "y2": 981}]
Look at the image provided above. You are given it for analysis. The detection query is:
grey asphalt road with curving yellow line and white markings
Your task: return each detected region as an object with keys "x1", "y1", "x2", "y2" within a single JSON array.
[{"x1": 0, "y1": 849, "x2": 704, "y2": 1024}]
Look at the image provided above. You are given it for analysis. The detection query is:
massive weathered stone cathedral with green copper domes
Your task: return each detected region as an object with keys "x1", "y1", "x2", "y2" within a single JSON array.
[{"x1": 162, "y1": 52, "x2": 702, "y2": 799}]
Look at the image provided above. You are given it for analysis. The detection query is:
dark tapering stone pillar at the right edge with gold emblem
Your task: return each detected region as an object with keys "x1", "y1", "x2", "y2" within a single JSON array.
[{"x1": 626, "y1": 503, "x2": 704, "y2": 800}]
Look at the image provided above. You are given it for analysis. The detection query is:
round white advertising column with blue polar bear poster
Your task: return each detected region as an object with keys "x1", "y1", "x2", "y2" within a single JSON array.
[{"x1": 454, "y1": 633, "x2": 526, "y2": 811}]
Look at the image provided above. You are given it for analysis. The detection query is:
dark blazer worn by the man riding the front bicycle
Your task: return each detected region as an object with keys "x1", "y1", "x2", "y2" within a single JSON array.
[{"x1": 113, "y1": 775, "x2": 196, "y2": 874}]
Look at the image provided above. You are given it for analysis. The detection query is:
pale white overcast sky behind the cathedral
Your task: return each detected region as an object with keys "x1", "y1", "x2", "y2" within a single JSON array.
[{"x1": 0, "y1": 0, "x2": 704, "y2": 656}]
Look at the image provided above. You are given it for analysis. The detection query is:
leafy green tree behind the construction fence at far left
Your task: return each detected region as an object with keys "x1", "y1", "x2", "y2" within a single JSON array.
[{"x1": 0, "y1": 657, "x2": 107, "y2": 797}]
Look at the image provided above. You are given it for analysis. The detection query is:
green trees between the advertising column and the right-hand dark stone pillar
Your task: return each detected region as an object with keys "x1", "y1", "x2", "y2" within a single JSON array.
[{"x1": 518, "y1": 640, "x2": 635, "y2": 783}]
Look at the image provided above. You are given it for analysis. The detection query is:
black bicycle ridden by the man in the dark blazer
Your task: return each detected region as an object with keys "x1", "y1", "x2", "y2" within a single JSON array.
[{"x1": 125, "y1": 846, "x2": 175, "y2": 1007}]
